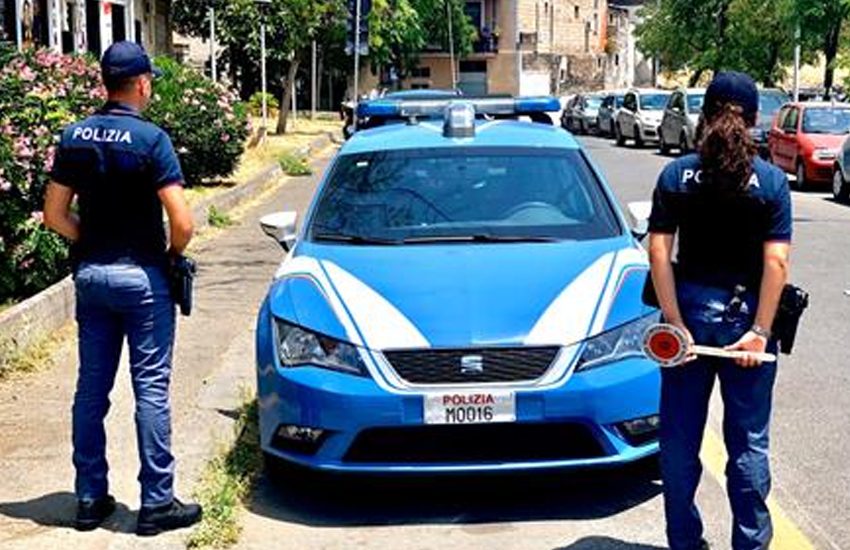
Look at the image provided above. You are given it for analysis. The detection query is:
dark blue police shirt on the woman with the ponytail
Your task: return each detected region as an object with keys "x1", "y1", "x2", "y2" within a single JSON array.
[{"x1": 649, "y1": 154, "x2": 792, "y2": 291}]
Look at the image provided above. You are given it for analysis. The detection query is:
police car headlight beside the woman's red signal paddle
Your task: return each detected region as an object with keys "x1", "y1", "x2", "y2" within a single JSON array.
[{"x1": 576, "y1": 311, "x2": 661, "y2": 372}]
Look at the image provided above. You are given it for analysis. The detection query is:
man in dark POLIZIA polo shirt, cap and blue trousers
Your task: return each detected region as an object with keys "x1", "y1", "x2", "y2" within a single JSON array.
[{"x1": 44, "y1": 42, "x2": 201, "y2": 535}]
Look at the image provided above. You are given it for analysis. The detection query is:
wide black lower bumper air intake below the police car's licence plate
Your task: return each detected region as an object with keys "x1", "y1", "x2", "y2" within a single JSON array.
[{"x1": 343, "y1": 423, "x2": 605, "y2": 464}]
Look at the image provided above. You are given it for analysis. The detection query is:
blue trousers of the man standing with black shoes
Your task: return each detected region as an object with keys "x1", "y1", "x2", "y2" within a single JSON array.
[{"x1": 73, "y1": 262, "x2": 175, "y2": 507}]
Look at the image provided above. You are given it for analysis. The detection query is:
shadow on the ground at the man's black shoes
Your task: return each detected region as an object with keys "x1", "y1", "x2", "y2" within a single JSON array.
[{"x1": 0, "y1": 492, "x2": 136, "y2": 533}]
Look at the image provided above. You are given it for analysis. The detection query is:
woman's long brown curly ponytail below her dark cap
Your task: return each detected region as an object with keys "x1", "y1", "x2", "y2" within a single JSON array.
[{"x1": 697, "y1": 103, "x2": 758, "y2": 193}]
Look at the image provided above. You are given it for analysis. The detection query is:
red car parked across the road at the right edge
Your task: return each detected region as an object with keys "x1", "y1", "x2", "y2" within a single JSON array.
[{"x1": 768, "y1": 103, "x2": 850, "y2": 189}]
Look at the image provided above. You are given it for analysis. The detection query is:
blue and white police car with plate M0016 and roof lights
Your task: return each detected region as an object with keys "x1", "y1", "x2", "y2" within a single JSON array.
[{"x1": 256, "y1": 98, "x2": 659, "y2": 473}]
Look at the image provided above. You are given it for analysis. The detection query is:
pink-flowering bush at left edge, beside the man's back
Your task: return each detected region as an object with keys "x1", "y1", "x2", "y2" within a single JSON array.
[{"x1": 0, "y1": 45, "x2": 105, "y2": 303}]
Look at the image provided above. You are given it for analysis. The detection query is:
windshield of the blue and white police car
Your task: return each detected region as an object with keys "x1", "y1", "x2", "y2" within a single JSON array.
[{"x1": 308, "y1": 147, "x2": 621, "y2": 244}]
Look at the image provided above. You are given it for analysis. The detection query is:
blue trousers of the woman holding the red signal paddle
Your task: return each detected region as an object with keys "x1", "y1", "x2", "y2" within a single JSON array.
[{"x1": 660, "y1": 283, "x2": 776, "y2": 550}]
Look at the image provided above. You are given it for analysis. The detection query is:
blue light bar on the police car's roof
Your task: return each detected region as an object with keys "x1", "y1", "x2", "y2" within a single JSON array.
[{"x1": 357, "y1": 96, "x2": 561, "y2": 118}]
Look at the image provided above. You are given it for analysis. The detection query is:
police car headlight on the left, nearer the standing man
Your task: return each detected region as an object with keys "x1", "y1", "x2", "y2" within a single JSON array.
[{"x1": 274, "y1": 319, "x2": 367, "y2": 376}]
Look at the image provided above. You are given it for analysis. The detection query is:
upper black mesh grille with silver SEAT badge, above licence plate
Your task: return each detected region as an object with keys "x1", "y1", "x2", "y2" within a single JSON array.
[{"x1": 384, "y1": 347, "x2": 559, "y2": 384}]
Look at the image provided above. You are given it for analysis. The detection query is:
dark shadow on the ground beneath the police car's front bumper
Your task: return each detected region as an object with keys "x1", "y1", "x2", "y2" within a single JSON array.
[{"x1": 249, "y1": 464, "x2": 661, "y2": 532}]
